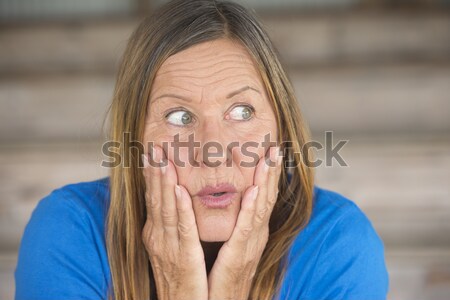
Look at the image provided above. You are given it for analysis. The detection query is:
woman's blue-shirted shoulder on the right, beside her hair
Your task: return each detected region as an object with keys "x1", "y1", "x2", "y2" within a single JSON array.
[{"x1": 285, "y1": 186, "x2": 388, "y2": 300}]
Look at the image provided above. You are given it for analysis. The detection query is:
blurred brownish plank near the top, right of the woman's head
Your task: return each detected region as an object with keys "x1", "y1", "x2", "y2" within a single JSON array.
[{"x1": 265, "y1": 12, "x2": 450, "y2": 66}]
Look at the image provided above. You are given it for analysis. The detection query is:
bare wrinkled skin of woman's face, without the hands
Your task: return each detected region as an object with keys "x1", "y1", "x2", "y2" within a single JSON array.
[{"x1": 144, "y1": 40, "x2": 277, "y2": 241}]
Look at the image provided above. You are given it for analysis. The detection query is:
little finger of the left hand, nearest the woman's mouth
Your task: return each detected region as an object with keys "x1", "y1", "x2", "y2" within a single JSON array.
[{"x1": 175, "y1": 185, "x2": 200, "y2": 249}]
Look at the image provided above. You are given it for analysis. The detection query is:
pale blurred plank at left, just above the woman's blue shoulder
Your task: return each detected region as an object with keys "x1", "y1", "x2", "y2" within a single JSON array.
[{"x1": 0, "y1": 143, "x2": 107, "y2": 251}]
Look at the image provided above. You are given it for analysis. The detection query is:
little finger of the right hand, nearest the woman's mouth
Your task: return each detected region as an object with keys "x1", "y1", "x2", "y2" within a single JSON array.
[{"x1": 227, "y1": 186, "x2": 259, "y2": 247}]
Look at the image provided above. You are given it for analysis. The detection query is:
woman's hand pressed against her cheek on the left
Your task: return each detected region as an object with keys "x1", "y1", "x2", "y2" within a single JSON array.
[{"x1": 142, "y1": 146, "x2": 208, "y2": 300}]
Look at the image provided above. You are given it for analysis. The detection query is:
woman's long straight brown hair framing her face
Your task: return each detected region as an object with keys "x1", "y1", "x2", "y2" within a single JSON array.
[{"x1": 106, "y1": 0, "x2": 314, "y2": 300}]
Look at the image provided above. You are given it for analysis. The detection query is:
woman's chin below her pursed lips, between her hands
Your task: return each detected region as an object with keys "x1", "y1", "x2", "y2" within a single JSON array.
[{"x1": 197, "y1": 213, "x2": 237, "y2": 242}]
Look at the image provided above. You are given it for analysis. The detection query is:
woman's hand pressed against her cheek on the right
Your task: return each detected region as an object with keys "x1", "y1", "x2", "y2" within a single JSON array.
[{"x1": 208, "y1": 147, "x2": 282, "y2": 300}]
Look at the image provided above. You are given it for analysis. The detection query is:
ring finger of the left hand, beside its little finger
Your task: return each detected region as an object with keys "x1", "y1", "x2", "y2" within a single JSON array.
[{"x1": 161, "y1": 149, "x2": 178, "y2": 239}]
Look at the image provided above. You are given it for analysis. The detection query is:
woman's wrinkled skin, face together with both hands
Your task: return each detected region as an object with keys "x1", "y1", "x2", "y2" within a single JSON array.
[{"x1": 142, "y1": 39, "x2": 281, "y2": 300}]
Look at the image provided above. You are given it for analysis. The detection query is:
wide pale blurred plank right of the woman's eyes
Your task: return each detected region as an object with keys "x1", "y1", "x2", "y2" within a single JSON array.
[{"x1": 291, "y1": 64, "x2": 450, "y2": 135}]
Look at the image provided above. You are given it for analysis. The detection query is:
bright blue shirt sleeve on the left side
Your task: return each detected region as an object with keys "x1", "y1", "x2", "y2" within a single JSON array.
[{"x1": 15, "y1": 190, "x2": 107, "y2": 300}]
